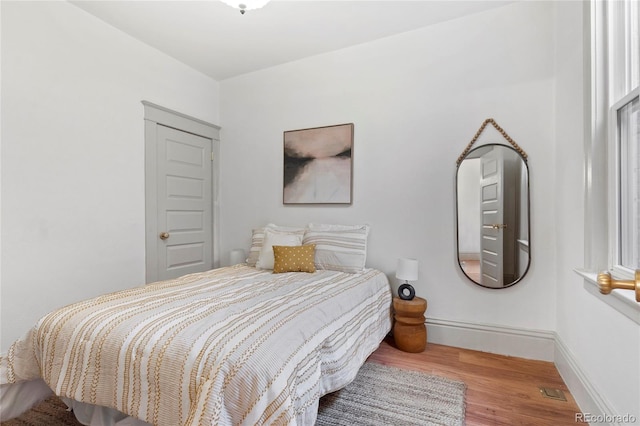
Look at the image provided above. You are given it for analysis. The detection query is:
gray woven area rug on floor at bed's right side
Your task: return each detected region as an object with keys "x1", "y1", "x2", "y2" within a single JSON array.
[{"x1": 316, "y1": 362, "x2": 466, "y2": 426}]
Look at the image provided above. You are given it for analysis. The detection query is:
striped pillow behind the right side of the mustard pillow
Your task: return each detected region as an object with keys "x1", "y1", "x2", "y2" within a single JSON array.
[{"x1": 302, "y1": 225, "x2": 369, "y2": 273}]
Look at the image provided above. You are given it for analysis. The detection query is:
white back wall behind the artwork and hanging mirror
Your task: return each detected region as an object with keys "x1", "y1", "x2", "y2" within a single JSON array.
[{"x1": 220, "y1": 2, "x2": 560, "y2": 330}]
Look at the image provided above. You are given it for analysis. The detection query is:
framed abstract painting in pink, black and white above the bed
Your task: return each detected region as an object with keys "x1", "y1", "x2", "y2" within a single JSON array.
[{"x1": 282, "y1": 123, "x2": 353, "y2": 204}]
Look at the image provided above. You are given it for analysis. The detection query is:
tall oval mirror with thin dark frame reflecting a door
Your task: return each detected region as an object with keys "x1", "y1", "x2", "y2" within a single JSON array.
[{"x1": 456, "y1": 144, "x2": 531, "y2": 288}]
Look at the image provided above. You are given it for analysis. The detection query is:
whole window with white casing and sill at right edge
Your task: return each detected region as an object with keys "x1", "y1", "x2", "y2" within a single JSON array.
[{"x1": 576, "y1": 0, "x2": 640, "y2": 324}]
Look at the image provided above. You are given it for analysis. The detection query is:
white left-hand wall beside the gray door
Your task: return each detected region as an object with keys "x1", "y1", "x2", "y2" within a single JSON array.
[{"x1": 0, "y1": 2, "x2": 219, "y2": 350}]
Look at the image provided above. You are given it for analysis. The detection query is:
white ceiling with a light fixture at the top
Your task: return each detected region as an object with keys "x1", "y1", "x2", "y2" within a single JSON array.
[{"x1": 71, "y1": 0, "x2": 512, "y2": 81}]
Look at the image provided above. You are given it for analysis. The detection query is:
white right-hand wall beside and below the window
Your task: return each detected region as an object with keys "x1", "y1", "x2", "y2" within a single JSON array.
[{"x1": 553, "y1": 2, "x2": 640, "y2": 424}]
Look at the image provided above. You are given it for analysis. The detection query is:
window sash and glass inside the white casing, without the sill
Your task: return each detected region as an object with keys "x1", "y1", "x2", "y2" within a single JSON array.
[{"x1": 594, "y1": 0, "x2": 640, "y2": 277}]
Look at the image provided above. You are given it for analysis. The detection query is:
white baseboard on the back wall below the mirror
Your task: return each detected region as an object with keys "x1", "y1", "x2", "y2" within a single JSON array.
[{"x1": 426, "y1": 318, "x2": 555, "y2": 362}]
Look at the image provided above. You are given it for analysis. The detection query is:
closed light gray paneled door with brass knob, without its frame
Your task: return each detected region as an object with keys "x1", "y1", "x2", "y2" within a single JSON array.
[{"x1": 157, "y1": 125, "x2": 213, "y2": 280}]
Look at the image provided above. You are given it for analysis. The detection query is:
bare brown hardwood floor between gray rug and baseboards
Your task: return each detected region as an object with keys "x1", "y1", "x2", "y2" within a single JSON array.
[{"x1": 369, "y1": 339, "x2": 580, "y2": 426}]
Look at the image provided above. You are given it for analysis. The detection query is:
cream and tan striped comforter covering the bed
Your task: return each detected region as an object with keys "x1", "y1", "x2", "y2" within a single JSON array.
[{"x1": 0, "y1": 265, "x2": 391, "y2": 426}]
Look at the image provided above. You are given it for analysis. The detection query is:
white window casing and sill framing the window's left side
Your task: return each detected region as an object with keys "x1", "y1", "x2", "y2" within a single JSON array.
[{"x1": 575, "y1": 2, "x2": 640, "y2": 324}]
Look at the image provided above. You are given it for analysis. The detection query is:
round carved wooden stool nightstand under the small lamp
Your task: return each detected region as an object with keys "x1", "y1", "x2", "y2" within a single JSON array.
[{"x1": 393, "y1": 297, "x2": 427, "y2": 352}]
